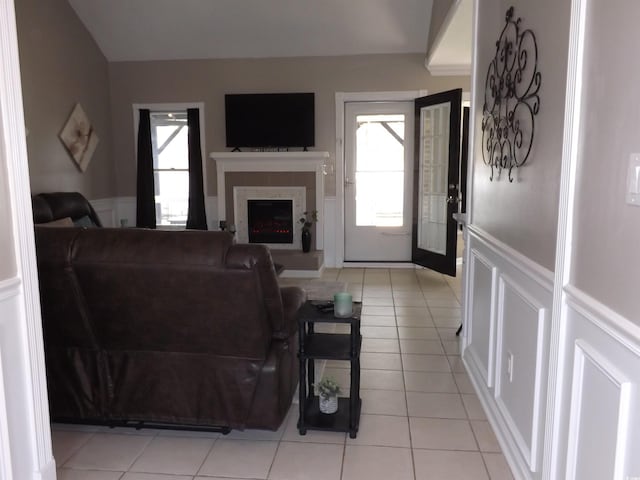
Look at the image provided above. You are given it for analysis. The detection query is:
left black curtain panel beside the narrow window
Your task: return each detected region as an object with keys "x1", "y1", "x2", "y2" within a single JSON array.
[{"x1": 136, "y1": 109, "x2": 156, "y2": 228}]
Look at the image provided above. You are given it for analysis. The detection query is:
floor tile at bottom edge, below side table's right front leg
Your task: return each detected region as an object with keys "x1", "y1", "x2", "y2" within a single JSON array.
[{"x1": 342, "y1": 445, "x2": 412, "y2": 480}]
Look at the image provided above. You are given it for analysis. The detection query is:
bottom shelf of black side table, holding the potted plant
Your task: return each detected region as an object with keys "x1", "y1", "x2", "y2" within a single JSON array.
[{"x1": 298, "y1": 395, "x2": 362, "y2": 438}]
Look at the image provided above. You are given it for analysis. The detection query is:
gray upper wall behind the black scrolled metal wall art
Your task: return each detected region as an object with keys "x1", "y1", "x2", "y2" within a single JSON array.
[{"x1": 472, "y1": 0, "x2": 570, "y2": 270}]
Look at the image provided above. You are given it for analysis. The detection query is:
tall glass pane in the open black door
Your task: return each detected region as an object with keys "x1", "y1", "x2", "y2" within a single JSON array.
[{"x1": 418, "y1": 103, "x2": 451, "y2": 255}]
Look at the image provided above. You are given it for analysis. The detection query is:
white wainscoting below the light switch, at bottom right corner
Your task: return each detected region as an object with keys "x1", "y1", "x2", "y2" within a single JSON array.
[{"x1": 552, "y1": 286, "x2": 640, "y2": 480}]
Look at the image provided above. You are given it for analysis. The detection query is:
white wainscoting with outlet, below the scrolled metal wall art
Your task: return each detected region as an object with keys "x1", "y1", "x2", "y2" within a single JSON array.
[{"x1": 463, "y1": 225, "x2": 553, "y2": 479}]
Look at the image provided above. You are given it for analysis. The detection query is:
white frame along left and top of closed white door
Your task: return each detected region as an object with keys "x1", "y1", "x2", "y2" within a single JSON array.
[{"x1": 334, "y1": 90, "x2": 428, "y2": 268}]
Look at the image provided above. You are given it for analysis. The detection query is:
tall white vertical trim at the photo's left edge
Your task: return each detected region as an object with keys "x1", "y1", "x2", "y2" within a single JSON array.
[{"x1": 0, "y1": 0, "x2": 55, "y2": 480}]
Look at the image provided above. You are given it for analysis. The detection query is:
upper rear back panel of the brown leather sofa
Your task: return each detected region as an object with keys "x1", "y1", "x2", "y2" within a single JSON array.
[{"x1": 73, "y1": 229, "x2": 271, "y2": 359}]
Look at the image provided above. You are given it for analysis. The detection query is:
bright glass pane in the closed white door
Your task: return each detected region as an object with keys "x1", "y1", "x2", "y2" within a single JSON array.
[{"x1": 355, "y1": 115, "x2": 405, "y2": 227}]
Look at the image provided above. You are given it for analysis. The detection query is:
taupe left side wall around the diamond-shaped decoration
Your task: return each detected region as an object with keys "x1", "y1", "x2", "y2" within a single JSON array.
[{"x1": 15, "y1": 0, "x2": 115, "y2": 198}]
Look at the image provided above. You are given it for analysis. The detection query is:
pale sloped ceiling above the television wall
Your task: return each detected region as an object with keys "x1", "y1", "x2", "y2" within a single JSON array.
[{"x1": 69, "y1": 0, "x2": 438, "y2": 61}]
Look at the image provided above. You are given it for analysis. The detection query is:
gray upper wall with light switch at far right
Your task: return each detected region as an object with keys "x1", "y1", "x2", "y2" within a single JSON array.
[{"x1": 571, "y1": 0, "x2": 640, "y2": 325}]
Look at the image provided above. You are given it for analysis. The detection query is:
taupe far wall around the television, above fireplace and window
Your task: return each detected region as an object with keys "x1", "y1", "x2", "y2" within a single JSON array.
[{"x1": 109, "y1": 54, "x2": 469, "y2": 196}]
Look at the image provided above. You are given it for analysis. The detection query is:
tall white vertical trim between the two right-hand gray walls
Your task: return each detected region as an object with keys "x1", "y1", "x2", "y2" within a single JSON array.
[{"x1": 543, "y1": 0, "x2": 588, "y2": 480}]
